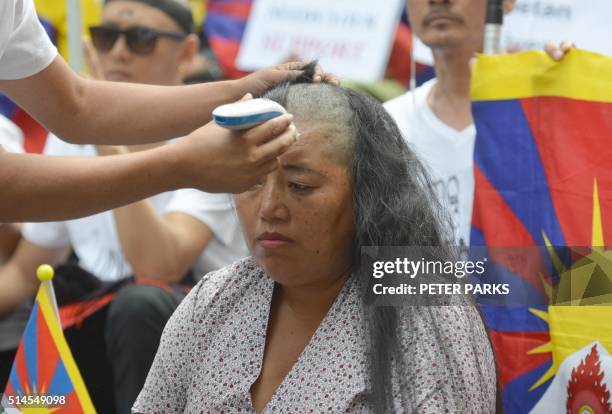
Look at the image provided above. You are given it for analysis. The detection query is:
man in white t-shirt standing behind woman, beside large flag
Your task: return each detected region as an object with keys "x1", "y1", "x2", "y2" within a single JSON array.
[{"x1": 385, "y1": 0, "x2": 572, "y2": 250}]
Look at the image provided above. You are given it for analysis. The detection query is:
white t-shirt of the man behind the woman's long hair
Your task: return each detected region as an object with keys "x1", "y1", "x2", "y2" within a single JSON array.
[{"x1": 384, "y1": 79, "x2": 476, "y2": 246}]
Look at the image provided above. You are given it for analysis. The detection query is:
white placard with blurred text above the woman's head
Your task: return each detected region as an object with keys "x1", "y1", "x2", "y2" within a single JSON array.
[{"x1": 237, "y1": 0, "x2": 404, "y2": 82}]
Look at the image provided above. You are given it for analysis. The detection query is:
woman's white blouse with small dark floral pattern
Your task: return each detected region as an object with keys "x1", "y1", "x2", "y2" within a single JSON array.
[{"x1": 132, "y1": 258, "x2": 496, "y2": 414}]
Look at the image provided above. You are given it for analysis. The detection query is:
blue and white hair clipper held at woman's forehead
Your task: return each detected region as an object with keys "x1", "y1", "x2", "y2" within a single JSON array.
[{"x1": 213, "y1": 98, "x2": 287, "y2": 130}]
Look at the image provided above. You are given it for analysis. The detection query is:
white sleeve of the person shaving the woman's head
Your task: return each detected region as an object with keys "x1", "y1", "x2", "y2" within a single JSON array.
[{"x1": 0, "y1": 0, "x2": 57, "y2": 80}]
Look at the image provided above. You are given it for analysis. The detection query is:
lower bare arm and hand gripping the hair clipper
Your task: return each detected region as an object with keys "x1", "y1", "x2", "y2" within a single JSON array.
[{"x1": 0, "y1": 115, "x2": 295, "y2": 222}]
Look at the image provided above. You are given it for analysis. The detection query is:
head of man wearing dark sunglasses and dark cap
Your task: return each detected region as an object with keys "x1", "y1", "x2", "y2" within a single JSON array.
[{"x1": 86, "y1": 0, "x2": 199, "y2": 86}]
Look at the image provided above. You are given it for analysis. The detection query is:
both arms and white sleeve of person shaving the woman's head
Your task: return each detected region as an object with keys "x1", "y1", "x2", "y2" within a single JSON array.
[{"x1": 0, "y1": 0, "x2": 333, "y2": 221}]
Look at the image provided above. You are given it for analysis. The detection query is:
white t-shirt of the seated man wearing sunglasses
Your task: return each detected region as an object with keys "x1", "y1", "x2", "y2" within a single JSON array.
[{"x1": 22, "y1": 134, "x2": 248, "y2": 281}]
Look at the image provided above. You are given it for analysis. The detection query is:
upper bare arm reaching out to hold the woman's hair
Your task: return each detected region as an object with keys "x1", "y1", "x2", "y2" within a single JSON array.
[{"x1": 0, "y1": 56, "x2": 302, "y2": 144}]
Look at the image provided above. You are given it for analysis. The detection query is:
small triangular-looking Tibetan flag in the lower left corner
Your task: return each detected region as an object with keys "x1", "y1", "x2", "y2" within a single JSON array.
[{"x1": 0, "y1": 274, "x2": 96, "y2": 414}]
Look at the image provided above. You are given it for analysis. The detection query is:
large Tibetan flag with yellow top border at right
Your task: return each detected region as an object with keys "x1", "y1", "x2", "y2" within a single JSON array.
[{"x1": 471, "y1": 49, "x2": 612, "y2": 414}]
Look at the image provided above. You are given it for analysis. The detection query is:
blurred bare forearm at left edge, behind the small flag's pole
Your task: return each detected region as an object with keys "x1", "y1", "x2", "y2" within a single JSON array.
[{"x1": 0, "y1": 239, "x2": 70, "y2": 318}]
